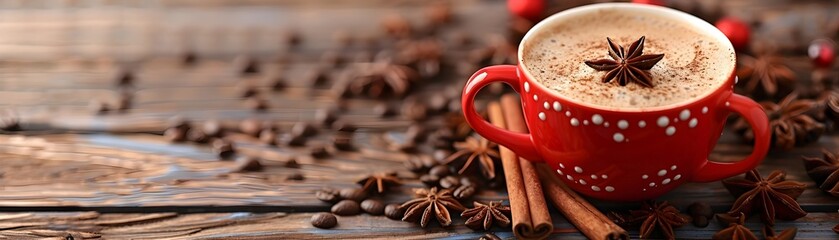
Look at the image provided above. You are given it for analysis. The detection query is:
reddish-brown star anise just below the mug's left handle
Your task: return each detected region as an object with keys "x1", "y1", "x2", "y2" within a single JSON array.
[{"x1": 444, "y1": 137, "x2": 500, "y2": 179}]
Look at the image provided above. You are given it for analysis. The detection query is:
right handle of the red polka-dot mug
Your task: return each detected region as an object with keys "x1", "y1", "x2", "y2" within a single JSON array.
[{"x1": 692, "y1": 94, "x2": 772, "y2": 182}]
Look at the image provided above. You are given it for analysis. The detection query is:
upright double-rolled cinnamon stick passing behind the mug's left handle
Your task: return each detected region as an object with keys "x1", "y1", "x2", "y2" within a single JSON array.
[{"x1": 488, "y1": 102, "x2": 553, "y2": 239}]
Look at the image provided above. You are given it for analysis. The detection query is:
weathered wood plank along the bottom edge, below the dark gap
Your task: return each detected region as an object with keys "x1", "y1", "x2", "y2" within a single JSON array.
[{"x1": 0, "y1": 212, "x2": 839, "y2": 239}]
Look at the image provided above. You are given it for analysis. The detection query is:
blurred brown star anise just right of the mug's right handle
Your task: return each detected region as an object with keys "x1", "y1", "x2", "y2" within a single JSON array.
[{"x1": 734, "y1": 93, "x2": 825, "y2": 149}]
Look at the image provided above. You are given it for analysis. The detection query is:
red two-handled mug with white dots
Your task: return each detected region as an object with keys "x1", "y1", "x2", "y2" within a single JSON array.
[{"x1": 462, "y1": 3, "x2": 771, "y2": 201}]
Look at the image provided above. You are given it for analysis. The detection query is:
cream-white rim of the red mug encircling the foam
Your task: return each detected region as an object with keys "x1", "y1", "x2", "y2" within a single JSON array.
[{"x1": 517, "y1": 3, "x2": 737, "y2": 112}]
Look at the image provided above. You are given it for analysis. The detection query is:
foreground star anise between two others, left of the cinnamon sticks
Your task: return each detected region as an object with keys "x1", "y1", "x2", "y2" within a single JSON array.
[{"x1": 399, "y1": 187, "x2": 465, "y2": 228}]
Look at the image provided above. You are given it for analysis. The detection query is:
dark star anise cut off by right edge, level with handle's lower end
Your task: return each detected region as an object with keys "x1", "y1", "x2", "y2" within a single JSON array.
[{"x1": 801, "y1": 149, "x2": 839, "y2": 197}]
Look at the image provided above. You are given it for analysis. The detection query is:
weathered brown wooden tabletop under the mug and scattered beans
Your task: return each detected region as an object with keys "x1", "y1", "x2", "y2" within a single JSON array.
[{"x1": 0, "y1": 0, "x2": 839, "y2": 239}]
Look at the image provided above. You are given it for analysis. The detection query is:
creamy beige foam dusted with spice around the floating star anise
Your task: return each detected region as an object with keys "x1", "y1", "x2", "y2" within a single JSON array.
[{"x1": 521, "y1": 8, "x2": 735, "y2": 108}]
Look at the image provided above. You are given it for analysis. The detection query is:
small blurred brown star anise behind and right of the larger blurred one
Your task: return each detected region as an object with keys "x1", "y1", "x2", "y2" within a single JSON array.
[{"x1": 400, "y1": 39, "x2": 443, "y2": 77}]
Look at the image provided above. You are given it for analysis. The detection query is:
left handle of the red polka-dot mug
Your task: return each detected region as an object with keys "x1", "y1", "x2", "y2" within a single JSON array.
[{"x1": 461, "y1": 65, "x2": 542, "y2": 161}]
